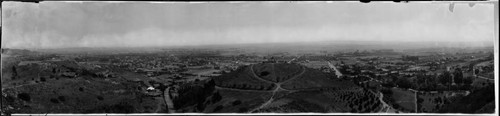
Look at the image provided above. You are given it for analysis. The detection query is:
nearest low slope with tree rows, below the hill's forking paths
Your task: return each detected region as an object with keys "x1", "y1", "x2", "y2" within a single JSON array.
[{"x1": 256, "y1": 88, "x2": 381, "y2": 113}]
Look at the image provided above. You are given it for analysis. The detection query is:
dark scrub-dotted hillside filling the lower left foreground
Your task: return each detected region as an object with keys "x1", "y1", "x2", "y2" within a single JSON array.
[{"x1": 1, "y1": 61, "x2": 166, "y2": 113}]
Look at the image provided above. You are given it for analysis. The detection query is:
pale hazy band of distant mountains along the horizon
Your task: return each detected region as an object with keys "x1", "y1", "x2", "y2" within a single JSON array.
[{"x1": 2, "y1": 40, "x2": 494, "y2": 54}]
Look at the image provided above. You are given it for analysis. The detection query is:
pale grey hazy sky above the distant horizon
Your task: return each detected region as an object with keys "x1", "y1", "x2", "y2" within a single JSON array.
[{"x1": 2, "y1": 2, "x2": 494, "y2": 48}]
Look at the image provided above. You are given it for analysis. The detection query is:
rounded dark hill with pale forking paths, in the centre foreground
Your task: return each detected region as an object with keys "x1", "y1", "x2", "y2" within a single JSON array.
[{"x1": 176, "y1": 63, "x2": 382, "y2": 113}]
